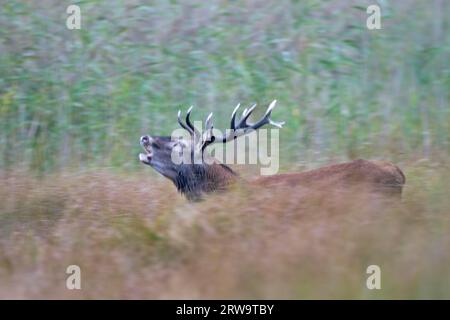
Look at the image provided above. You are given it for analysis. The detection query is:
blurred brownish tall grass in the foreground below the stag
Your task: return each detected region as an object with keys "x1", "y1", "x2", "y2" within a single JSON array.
[{"x1": 0, "y1": 162, "x2": 450, "y2": 299}]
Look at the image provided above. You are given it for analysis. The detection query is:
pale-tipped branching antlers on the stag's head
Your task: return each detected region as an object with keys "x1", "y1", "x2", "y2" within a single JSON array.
[{"x1": 178, "y1": 100, "x2": 284, "y2": 151}]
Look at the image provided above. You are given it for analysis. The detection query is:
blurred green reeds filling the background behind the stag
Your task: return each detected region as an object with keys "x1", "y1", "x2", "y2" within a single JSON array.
[{"x1": 0, "y1": 0, "x2": 450, "y2": 172}]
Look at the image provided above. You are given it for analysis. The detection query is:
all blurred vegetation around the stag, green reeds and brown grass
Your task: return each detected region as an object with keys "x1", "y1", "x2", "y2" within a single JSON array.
[{"x1": 0, "y1": 0, "x2": 450, "y2": 299}]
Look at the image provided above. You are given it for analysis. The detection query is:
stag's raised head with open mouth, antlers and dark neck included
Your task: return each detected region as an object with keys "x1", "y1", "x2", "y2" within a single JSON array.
[{"x1": 139, "y1": 100, "x2": 284, "y2": 199}]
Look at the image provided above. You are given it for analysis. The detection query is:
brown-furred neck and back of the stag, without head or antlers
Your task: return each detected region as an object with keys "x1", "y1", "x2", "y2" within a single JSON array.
[{"x1": 175, "y1": 159, "x2": 405, "y2": 199}]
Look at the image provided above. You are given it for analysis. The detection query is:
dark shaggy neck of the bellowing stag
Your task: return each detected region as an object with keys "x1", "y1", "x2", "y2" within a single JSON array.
[{"x1": 174, "y1": 163, "x2": 237, "y2": 200}]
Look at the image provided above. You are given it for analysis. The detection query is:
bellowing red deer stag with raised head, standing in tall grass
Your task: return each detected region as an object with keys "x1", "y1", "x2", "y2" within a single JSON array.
[{"x1": 139, "y1": 100, "x2": 405, "y2": 200}]
